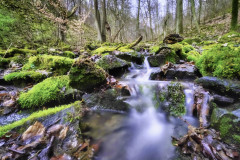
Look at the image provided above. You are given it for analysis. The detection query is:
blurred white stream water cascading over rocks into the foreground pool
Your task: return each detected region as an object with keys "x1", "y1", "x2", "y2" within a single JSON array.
[{"x1": 91, "y1": 59, "x2": 211, "y2": 160}]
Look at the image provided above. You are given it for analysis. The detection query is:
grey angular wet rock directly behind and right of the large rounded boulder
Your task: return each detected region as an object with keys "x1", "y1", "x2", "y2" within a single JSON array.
[{"x1": 96, "y1": 55, "x2": 130, "y2": 76}]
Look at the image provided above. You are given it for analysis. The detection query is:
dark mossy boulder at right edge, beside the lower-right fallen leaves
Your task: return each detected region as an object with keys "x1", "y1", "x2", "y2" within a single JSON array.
[{"x1": 211, "y1": 108, "x2": 240, "y2": 147}]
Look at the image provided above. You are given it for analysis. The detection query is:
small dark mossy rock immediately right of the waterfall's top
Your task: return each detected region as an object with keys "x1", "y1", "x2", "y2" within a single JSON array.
[{"x1": 147, "y1": 54, "x2": 166, "y2": 67}]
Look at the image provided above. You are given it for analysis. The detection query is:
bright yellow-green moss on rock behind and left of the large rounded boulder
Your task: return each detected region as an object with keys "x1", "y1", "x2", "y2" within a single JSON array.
[{"x1": 22, "y1": 55, "x2": 74, "y2": 75}]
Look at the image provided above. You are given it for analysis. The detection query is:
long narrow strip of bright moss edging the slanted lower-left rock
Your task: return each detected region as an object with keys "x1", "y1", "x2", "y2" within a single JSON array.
[{"x1": 0, "y1": 101, "x2": 81, "y2": 137}]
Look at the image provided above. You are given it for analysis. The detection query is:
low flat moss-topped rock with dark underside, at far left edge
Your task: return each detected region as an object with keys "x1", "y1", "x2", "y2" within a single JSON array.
[{"x1": 4, "y1": 71, "x2": 48, "y2": 85}]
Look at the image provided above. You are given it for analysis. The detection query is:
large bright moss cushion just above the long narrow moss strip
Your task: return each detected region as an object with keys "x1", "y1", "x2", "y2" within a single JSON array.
[{"x1": 18, "y1": 76, "x2": 70, "y2": 108}]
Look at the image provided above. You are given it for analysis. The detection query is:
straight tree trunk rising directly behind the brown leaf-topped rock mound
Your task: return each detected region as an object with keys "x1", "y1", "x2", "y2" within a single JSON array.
[{"x1": 176, "y1": 0, "x2": 183, "y2": 34}]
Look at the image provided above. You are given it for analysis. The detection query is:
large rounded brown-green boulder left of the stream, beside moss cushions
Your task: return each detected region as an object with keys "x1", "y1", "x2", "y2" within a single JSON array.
[{"x1": 69, "y1": 58, "x2": 106, "y2": 91}]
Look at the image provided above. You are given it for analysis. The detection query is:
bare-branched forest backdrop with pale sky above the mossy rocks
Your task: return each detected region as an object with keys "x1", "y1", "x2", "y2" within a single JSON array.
[{"x1": 0, "y1": 0, "x2": 238, "y2": 49}]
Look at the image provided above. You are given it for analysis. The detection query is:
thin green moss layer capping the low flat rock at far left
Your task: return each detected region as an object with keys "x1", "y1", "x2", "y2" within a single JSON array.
[{"x1": 4, "y1": 71, "x2": 46, "y2": 82}]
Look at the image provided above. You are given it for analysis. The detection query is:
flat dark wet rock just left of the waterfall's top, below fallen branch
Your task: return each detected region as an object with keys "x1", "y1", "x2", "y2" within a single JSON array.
[{"x1": 114, "y1": 51, "x2": 144, "y2": 65}]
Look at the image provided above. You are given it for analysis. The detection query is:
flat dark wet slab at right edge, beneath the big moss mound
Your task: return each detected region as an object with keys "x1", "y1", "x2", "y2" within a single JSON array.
[{"x1": 195, "y1": 77, "x2": 240, "y2": 99}]
